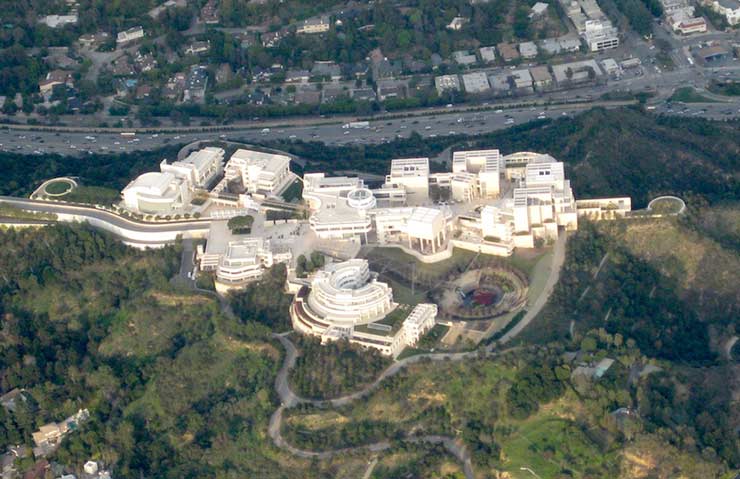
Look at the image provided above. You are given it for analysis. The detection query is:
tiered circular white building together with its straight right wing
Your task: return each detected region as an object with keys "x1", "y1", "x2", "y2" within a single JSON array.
[{"x1": 290, "y1": 259, "x2": 437, "y2": 357}]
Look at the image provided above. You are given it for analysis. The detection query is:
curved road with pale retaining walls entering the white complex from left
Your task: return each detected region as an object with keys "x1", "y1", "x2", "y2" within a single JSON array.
[{"x1": 0, "y1": 196, "x2": 212, "y2": 248}]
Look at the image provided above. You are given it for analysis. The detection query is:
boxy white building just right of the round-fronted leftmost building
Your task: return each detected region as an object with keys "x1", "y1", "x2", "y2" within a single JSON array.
[{"x1": 225, "y1": 149, "x2": 290, "y2": 196}]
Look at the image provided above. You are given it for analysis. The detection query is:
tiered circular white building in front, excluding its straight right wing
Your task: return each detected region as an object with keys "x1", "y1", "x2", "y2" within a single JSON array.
[{"x1": 290, "y1": 259, "x2": 396, "y2": 336}]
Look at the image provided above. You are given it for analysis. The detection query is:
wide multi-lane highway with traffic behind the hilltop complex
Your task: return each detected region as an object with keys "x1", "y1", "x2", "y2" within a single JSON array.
[{"x1": 0, "y1": 96, "x2": 740, "y2": 156}]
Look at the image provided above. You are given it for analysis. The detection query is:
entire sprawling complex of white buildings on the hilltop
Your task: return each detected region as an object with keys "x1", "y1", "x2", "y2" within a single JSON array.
[{"x1": 95, "y1": 147, "x2": 631, "y2": 357}]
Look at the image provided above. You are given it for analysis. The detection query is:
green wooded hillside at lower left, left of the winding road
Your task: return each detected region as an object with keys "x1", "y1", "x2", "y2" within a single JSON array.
[{"x1": 0, "y1": 226, "x2": 318, "y2": 478}]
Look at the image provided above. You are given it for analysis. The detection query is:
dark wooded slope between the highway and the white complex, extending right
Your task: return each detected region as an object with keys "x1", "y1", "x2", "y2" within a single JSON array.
[{"x1": 273, "y1": 108, "x2": 740, "y2": 207}]
